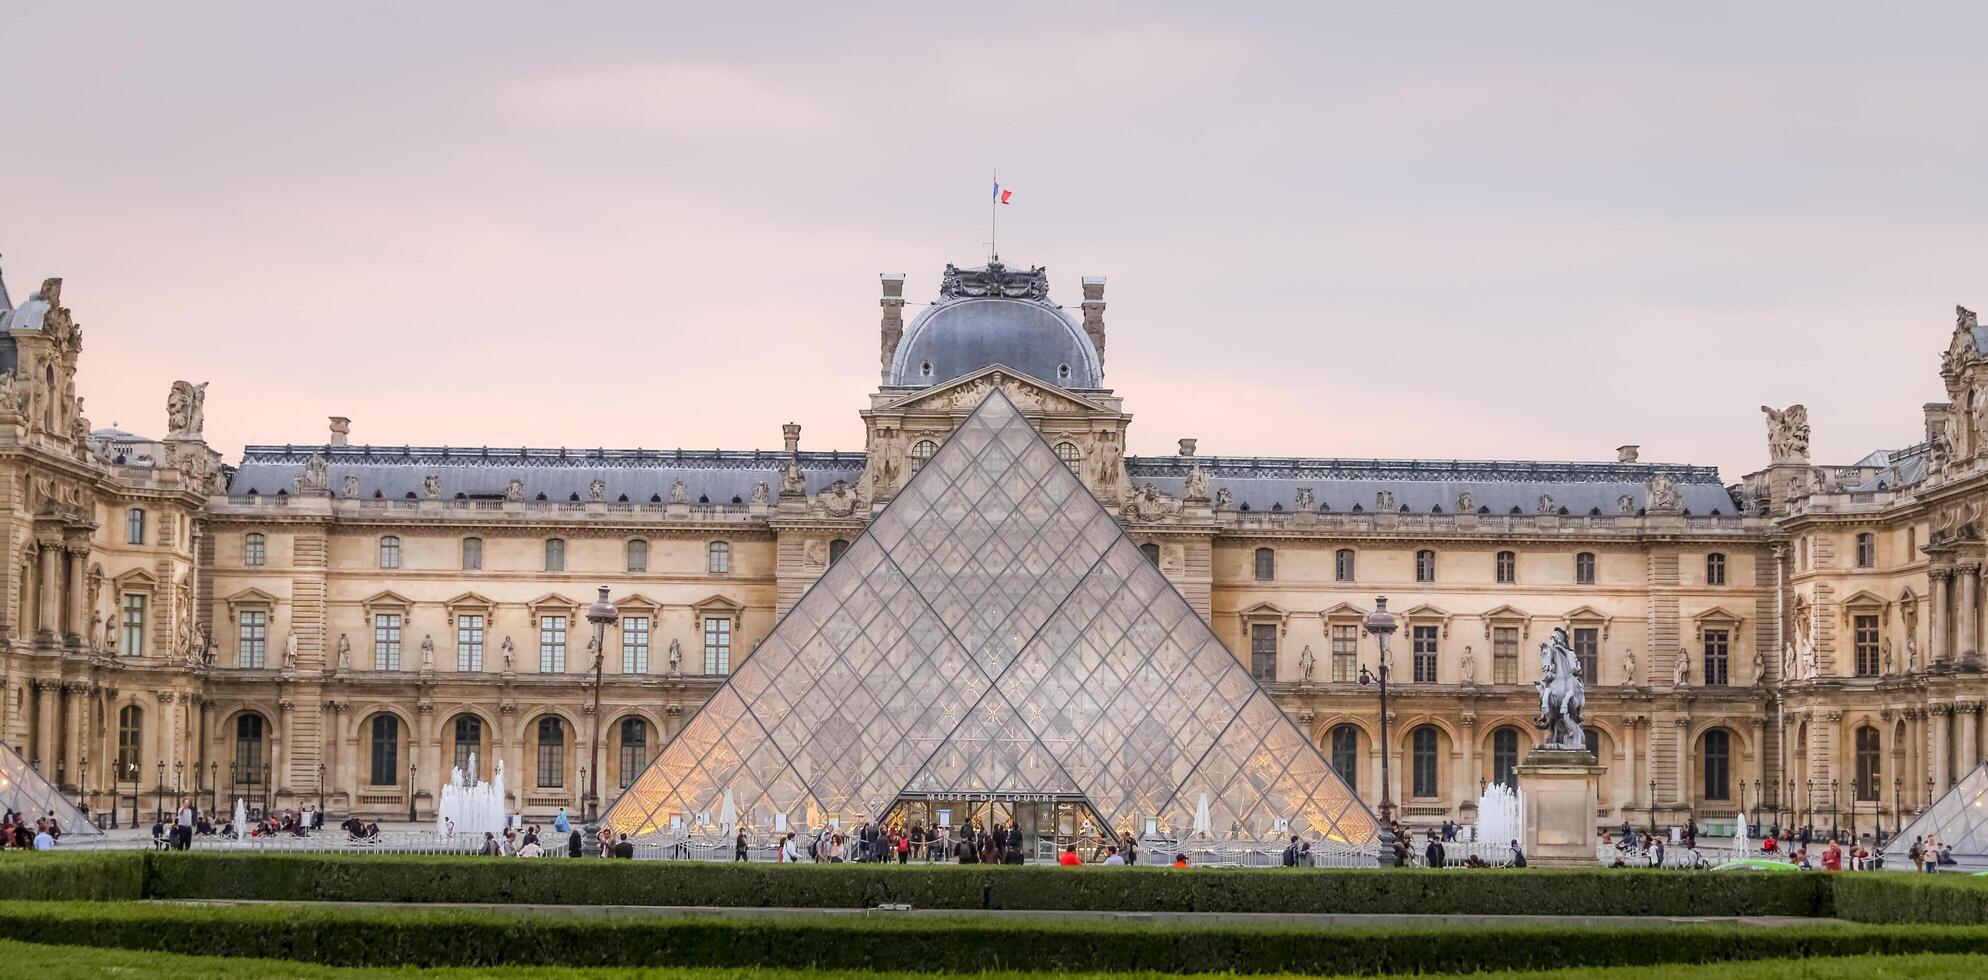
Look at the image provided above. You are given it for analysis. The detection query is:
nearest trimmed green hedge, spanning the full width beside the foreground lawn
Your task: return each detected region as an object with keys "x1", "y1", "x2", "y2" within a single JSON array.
[{"x1": 0, "y1": 902, "x2": 1988, "y2": 974}]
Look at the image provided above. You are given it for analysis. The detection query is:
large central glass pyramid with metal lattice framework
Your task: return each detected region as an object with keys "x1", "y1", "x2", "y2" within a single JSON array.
[{"x1": 604, "y1": 388, "x2": 1376, "y2": 843}]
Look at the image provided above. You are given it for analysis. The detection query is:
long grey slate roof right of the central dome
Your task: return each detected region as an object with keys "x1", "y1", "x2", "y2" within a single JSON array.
[{"x1": 1125, "y1": 455, "x2": 1740, "y2": 515}]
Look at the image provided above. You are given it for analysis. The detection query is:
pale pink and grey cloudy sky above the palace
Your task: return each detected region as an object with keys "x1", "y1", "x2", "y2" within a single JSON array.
[{"x1": 0, "y1": 0, "x2": 1988, "y2": 481}]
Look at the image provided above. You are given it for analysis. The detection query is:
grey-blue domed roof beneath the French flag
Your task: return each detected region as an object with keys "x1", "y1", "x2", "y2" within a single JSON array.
[{"x1": 891, "y1": 260, "x2": 1103, "y2": 388}]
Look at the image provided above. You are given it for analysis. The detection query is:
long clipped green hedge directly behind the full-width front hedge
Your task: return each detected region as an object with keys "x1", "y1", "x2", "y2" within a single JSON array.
[{"x1": 145, "y1": 853, "x2": 1831, "y2": 916}]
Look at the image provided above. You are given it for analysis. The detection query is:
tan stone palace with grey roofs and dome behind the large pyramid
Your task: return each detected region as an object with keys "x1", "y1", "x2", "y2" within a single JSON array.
[{"x1": 0, "y1": 254, "x2": 1988, "y2": 829}]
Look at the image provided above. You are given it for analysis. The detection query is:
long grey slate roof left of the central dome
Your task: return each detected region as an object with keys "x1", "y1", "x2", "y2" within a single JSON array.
[{"x1": 229, "y1": 445, "x2": 863, "y2": 503}]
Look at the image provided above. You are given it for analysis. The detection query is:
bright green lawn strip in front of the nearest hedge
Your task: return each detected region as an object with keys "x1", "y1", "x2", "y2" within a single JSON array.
[{"x1": 11, "y1": 940, "x2": 1988, "y2": 980}]
